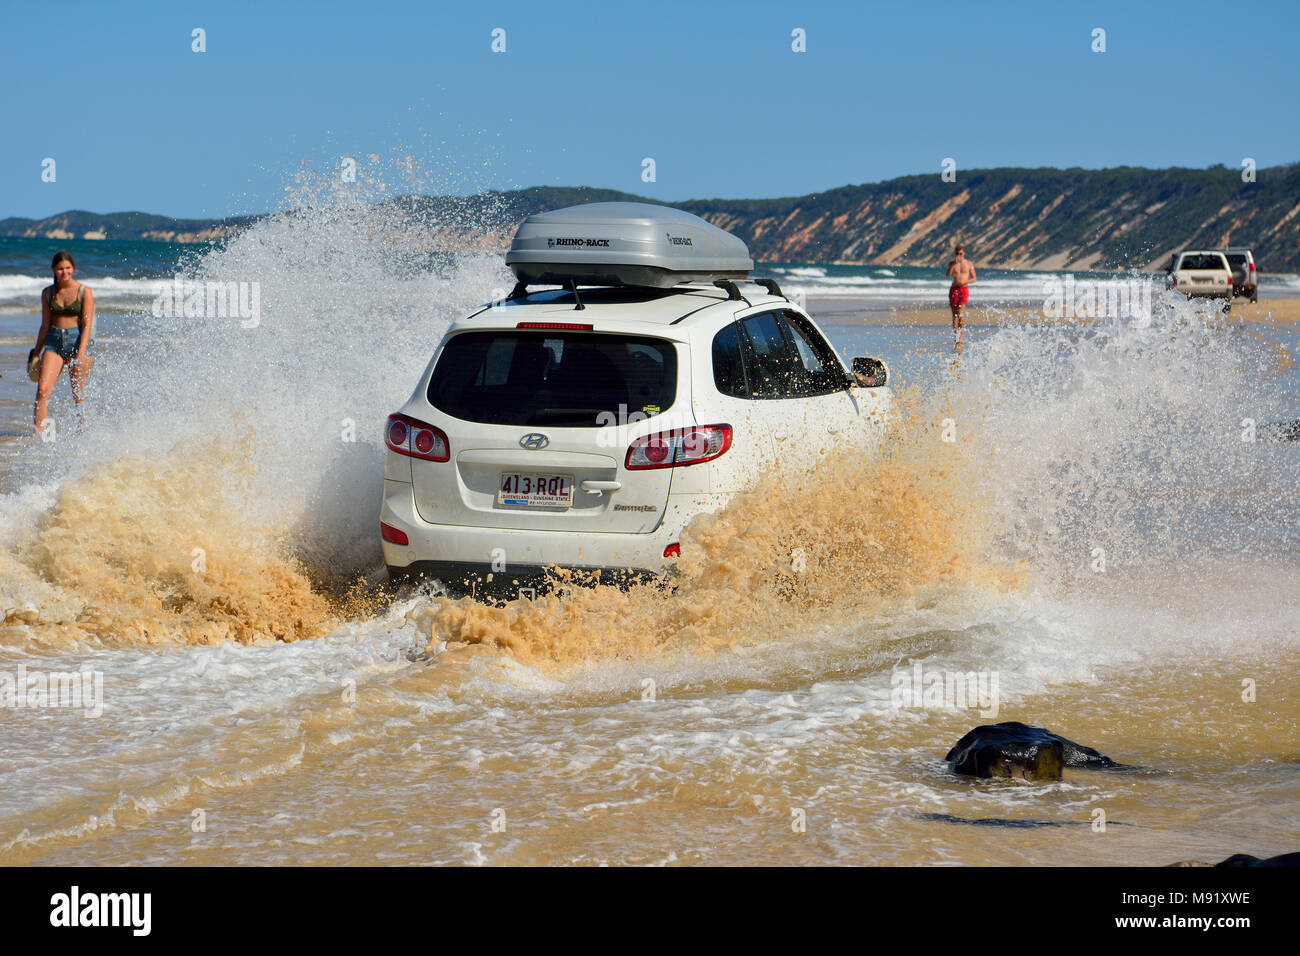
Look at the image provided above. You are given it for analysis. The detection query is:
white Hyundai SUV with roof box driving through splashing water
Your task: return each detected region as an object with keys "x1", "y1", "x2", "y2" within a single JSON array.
[{"x1": 380, "y1": 203, "x2": 889, "y2": 597}]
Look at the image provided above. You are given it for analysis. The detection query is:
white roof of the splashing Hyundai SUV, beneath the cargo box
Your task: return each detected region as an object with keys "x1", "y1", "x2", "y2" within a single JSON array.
[{"x1": 449, "y1": 282, "x2": 796, "y2": 338}]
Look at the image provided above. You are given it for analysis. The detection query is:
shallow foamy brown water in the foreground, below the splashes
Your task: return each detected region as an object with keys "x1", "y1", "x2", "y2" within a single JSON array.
[{"x1": 3, "y1": 591, "x2": 1300, "y2": 865}]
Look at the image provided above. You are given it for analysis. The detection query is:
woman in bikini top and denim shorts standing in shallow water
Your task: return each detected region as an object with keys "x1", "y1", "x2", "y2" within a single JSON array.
[{"x1": 31, "y1": 252, "x2": 95, "y2": 432}]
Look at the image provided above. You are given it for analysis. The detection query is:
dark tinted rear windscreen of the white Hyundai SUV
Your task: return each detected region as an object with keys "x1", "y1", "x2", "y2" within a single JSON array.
[{"x1": 429, "y1": 330, "x2": 677, "y2": 428}]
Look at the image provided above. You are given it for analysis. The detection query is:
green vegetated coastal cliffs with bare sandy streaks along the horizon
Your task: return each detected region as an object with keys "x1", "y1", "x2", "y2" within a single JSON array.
[{"x1": 0, "y1": 164, "x2": 1300, "y2": 272}]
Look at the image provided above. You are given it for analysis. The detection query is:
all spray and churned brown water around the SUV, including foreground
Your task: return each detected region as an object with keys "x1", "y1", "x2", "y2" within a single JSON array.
[{"x1": 0, "y1": 171, "x2": 1300, "y2": 864}]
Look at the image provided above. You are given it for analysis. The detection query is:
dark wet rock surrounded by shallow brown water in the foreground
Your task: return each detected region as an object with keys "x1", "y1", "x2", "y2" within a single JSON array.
[{"x1": 944, "y1": 721, "x2": 1123, "y2": 780}]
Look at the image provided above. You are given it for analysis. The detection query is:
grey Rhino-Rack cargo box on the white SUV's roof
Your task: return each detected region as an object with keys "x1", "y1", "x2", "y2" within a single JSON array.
[{"x1": 506, "y1": 203, "x2": 754, "y2": 289}]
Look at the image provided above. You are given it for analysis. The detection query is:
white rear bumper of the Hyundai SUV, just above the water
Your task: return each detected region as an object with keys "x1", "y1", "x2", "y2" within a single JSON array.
[{"x1": 380, "y1": 479, "x2": 731, "y2": 588}]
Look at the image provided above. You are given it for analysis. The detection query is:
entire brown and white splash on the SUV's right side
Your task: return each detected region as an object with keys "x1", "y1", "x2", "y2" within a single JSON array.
[{"x1": 410, "y1": 302, "x2": 1300, "y2": 666}]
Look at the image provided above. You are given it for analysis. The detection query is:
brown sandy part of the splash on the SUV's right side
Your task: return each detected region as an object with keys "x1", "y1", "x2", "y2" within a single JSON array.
[{"x1": 408, "y1": 398, "x2": 1017, "y2": 669}]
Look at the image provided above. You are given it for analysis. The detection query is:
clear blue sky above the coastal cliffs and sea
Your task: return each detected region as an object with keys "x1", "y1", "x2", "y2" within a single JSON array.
[{"x1": 0, "y1": 0, "x2": 1300, "y2": 217}]
